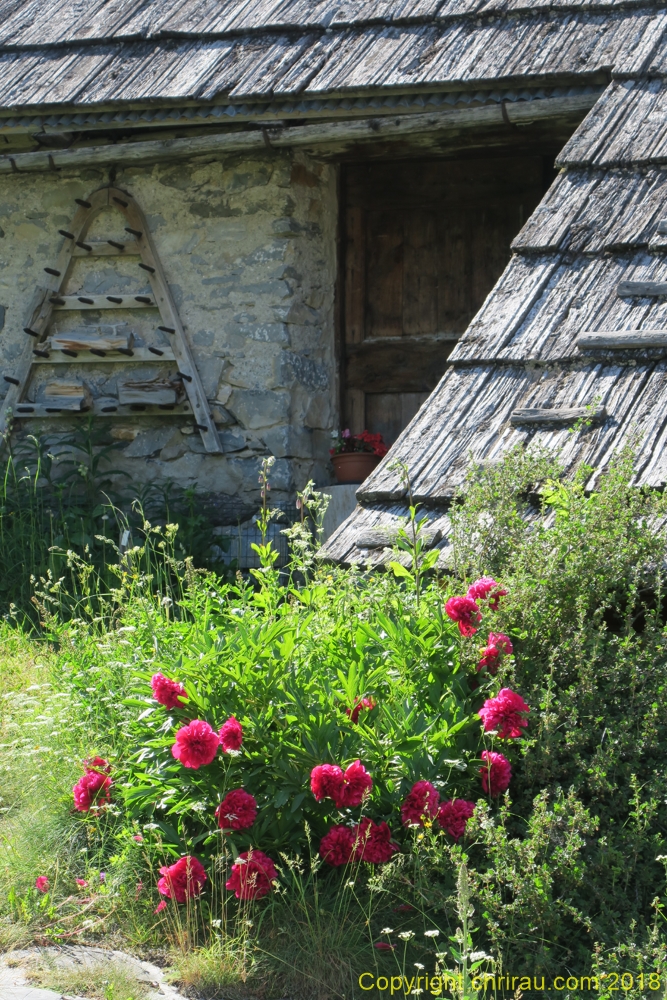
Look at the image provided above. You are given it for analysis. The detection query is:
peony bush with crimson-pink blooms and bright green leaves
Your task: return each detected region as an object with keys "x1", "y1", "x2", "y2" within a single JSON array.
[{"x1": 116, "y1": 577, "x2": 530, "y2": 902}]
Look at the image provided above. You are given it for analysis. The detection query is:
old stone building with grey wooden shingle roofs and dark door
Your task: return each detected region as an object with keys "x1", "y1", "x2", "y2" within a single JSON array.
[{"x1": 0, "y1": 0, "x2": 667, "y2": 560}]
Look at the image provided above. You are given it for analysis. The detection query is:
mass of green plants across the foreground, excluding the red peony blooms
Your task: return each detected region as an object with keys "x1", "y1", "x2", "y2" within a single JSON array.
[{"x1": 0, "y1": 451, "x2": 667, "y2": 1000}]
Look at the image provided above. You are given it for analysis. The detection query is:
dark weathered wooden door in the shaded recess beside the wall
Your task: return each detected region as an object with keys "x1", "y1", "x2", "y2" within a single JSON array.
[{"x1": 342, "y1": 156, "x2": 545, "y2": 443}]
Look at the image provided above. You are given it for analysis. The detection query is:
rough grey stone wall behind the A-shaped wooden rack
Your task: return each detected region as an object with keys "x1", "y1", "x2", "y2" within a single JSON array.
[{"x1": 0, "y1": 150, "x2": 338, "y2": 523}]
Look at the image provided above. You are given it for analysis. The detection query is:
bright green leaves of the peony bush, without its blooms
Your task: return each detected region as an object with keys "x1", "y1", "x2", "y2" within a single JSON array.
[{"x1": 121, "y1": 574, "x2": 478, "y2": 852}]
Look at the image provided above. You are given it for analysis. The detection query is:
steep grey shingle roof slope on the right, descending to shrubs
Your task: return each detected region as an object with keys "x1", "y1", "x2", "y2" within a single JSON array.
[{"x1": 327, "y1": 1, "x2": 667, "y2": 562}]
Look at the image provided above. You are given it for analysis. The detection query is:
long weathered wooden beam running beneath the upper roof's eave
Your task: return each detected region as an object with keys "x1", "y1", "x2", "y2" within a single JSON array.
[{"x1": 0, "y1": 93, "x2": 599, "y2": 174}]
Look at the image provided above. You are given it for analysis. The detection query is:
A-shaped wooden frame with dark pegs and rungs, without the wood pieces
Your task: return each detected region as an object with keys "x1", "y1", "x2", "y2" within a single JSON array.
[{"x1": 0, "y1": 187, "x2": 222, "y2": 454}]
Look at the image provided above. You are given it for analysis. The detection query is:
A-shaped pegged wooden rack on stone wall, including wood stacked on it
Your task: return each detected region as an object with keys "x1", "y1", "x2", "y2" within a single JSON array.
[{"x1": 0, "y1": 187, "x2": 222, "y2": 454}]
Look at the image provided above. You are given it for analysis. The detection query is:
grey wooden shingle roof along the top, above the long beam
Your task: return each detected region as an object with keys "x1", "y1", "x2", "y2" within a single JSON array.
[{"x1": 0, "y1": 0, "x2": 667, "y2": 115}]
